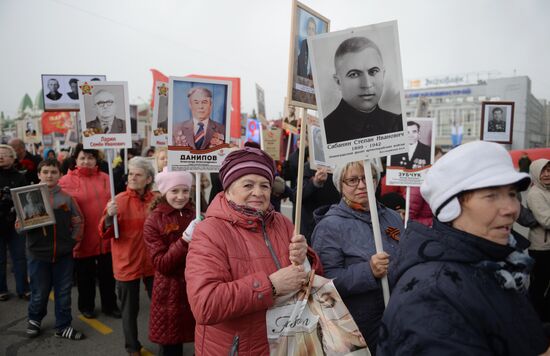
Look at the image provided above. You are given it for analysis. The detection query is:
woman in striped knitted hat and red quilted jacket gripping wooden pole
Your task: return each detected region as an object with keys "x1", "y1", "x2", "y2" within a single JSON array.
[{"x1": 185, "y1": 147, "x2": 318, "y2": 356}]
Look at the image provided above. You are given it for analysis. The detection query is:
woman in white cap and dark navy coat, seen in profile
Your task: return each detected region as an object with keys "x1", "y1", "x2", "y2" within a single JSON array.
[{"x1": 378, "y1": 141, "x2": 548, "y2": 355}]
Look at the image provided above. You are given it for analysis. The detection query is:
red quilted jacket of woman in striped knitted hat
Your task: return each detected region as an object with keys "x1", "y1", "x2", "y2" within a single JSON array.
[{"x1": 185, "y1": 192, "x2": 321, "y2": 356}]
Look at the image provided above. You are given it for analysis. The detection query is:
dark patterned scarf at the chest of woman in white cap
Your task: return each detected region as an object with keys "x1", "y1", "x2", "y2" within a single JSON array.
[{"x1": 476, "y1": 234, "x2": 535, "y2": 293}]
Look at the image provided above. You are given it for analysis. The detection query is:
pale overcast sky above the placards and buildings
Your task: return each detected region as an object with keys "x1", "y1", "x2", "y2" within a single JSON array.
[{"x1": 0, "y1": 0, "x2": 550, "y2": 118}]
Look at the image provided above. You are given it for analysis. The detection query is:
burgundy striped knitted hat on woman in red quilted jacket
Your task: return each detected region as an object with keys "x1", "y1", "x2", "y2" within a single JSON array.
[{"x1": 220, "y1": 147, "x2": 275, "y2": 190}]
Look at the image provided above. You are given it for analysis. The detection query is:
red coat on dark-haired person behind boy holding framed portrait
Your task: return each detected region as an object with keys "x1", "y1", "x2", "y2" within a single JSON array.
[{"x1": 59, "y1": 167, "x2": 111, "y2": 258}]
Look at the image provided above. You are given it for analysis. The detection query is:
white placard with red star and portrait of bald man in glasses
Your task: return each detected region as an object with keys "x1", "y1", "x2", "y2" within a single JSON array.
[{"x1": 78, "y1": 82, "x2": 132, "y2": 149}]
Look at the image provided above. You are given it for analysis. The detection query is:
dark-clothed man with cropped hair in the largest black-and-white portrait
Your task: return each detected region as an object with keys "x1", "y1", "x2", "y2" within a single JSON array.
[{"x1": 324, "y1": 37, "x2": 403, "y2": 144}]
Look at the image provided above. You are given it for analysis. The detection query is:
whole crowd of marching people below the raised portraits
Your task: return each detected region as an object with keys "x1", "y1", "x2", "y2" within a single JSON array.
[{"x1": 0, "y1": 139, "x2": 550, "y2": 355}]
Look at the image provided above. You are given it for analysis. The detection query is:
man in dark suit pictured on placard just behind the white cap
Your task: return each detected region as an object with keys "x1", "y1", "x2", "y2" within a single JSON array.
[{"x1": 391, "y1": 121, "x2": 431, "y2": 169}]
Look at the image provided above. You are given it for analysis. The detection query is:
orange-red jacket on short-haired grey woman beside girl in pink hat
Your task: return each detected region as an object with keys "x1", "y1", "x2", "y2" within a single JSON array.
[{"x1": 98, "y1": 188, "x2": 155, "y2": 282}]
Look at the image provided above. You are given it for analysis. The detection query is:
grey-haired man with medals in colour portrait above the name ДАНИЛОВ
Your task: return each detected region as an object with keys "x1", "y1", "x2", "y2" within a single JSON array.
[{"x1": 173, "y1": 87, "x2": 225, "y2": 150}]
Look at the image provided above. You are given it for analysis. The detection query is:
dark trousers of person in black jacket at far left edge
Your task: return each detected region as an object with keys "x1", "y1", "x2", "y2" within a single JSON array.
[{"x1": 0, "y1": 226, "x2": 29, "y2": 295}]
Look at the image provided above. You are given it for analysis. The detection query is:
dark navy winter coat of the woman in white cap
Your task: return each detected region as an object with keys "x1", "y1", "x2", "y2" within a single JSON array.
[{"x1": 377, "y1": 219, "x2": 548, "y2": 356}]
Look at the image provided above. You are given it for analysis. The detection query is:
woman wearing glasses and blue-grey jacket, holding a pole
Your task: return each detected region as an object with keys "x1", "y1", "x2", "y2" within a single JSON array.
[{"x1": 311, "y1": 162, "x2": 403, "y2": 355}]
